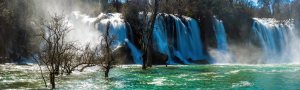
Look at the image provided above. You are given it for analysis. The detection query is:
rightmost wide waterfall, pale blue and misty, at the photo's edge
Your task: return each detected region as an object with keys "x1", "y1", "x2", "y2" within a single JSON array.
[{"x1": 252, "y1": 18, "x2": 300, "y2": 63}]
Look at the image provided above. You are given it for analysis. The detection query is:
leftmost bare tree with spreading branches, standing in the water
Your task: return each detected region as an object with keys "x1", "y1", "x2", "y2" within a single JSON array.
[{"x1": 38, "y1": 14, "x2": 74, "y2": 88}]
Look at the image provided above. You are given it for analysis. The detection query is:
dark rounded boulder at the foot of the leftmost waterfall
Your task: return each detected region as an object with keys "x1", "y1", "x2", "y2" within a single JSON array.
[{"x1": 113, "y1": 44, "x2": 135, "y2": 64}]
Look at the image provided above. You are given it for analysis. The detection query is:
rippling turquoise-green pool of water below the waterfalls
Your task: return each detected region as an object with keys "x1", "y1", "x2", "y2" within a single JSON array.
[{"x1": 0, "y1": 64, "x2": 300, "y2": 89}]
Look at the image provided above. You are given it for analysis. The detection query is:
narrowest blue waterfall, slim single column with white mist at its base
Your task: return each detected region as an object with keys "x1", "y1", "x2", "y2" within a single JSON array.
[{"x1": 209, "y1": 18, "x2": 235, "y2": 63}]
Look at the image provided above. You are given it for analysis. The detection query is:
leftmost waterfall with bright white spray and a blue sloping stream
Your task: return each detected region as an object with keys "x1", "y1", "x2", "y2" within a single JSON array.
[{"x1": 67, "y1": 11, "x2": 142, "y2": 64}]
